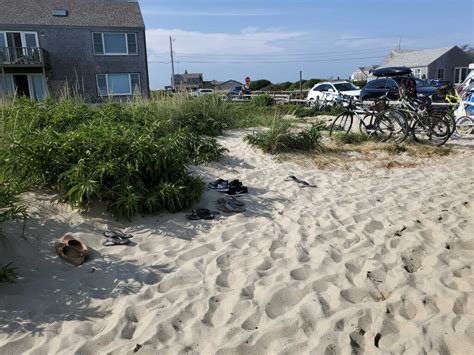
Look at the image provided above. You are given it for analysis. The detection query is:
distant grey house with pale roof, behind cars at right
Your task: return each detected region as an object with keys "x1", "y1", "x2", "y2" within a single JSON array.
[{"x1": 380, "y1": 46, "x2": 472, "y2": 84}]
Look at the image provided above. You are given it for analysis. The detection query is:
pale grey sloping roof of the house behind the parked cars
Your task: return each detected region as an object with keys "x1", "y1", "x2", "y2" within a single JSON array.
[{"x1": 381, "y1": 46, "x2": 456, "y2": 68}]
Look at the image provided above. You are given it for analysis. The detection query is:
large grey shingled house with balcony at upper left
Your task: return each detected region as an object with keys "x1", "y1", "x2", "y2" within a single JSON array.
[{"x1": 0, "y1": 0, "x2": 149, "y2": 101}]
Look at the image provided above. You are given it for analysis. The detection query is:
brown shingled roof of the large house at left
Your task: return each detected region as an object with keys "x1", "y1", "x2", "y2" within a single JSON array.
[{"x1": 0, "y1": 0, "x2": 145, "y2": 28}]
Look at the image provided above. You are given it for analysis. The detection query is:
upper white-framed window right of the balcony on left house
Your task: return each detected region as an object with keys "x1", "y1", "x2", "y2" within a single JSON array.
[{"x1": 92, "y1": 32, "x2": 138, "y2": 55}]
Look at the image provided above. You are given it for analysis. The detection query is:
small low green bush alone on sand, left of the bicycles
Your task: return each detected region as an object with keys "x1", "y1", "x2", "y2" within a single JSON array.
[{"x1": 245, "y1": 115, "x2": 322, "y2": 154}]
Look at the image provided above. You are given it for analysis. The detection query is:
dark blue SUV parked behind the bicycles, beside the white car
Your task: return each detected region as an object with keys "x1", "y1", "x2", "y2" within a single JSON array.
[{"x1": 360, "y1": 76, "x2": 438, "y2": 101}]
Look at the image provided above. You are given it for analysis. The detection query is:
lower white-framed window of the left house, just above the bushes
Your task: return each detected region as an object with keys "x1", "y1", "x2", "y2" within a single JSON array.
[{"x1": 97, "y1": 74, "x2": 140, "y2": 96}]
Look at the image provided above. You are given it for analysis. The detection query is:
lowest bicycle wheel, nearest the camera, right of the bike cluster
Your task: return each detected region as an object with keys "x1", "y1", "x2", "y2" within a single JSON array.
[{"x1": 412, "y1": 118, "x2": 451, "y2": 147}]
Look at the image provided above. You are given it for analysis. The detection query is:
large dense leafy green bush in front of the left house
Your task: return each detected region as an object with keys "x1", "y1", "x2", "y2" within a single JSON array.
[{"x1": 1, "y1": 96, "x2": 228, "y2": 218}]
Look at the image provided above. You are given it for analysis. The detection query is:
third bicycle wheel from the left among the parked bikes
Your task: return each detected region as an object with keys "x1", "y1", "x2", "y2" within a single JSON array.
[{"x1": 375, "y1": 109, "x2": 409, "y2": 144}]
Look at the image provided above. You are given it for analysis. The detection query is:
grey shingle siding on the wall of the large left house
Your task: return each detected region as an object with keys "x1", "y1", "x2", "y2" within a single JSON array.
[{"x1": 0, "y1": 25, "x2": 149, "y2": 101}]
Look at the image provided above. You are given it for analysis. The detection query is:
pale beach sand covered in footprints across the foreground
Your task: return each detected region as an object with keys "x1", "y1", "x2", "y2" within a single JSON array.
[{"x1": 0, "y1": 131, "x2": 474, "y2": 354}]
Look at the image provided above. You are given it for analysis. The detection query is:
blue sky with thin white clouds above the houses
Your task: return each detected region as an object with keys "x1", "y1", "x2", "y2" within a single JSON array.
[{"x1": 140, "y1": 0, "x2": 474, "y2": 89}]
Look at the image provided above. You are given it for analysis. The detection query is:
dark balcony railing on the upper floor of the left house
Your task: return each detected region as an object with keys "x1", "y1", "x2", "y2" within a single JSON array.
[{"x1": 0, "y1": 47, "x2": 49, "y2": 67}]
